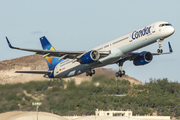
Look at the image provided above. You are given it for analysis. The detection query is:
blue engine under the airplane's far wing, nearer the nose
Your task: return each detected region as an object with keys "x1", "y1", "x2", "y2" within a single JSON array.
[{"x1": 133, "y1": 51, "x2": 153, "y2": 66}]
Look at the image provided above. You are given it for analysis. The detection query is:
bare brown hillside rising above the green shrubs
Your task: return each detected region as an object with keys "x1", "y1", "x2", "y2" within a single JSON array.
[{"x1": 0, "y1": 54, "x2": 142, "y2": 84}]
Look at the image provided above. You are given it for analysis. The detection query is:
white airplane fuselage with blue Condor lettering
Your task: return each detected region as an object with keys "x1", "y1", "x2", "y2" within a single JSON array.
[{"x1": 54, "y1": 21, "x2": 174, "y2": 78}]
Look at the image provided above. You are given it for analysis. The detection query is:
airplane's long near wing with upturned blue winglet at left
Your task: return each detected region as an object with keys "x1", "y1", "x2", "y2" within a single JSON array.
[{"x1": 6, "y1": 37, "x2": 109, "y2": 59}]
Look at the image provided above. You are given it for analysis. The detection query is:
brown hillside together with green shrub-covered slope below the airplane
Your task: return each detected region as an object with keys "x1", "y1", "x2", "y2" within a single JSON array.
[{"x1": 0, "y1": 55, "x2": 180, "y2": 117}]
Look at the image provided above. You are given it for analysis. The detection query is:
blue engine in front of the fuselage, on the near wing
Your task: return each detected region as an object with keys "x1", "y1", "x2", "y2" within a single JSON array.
[{"x1": 80, "y1": 50, "x2": 100, "y2": 64}]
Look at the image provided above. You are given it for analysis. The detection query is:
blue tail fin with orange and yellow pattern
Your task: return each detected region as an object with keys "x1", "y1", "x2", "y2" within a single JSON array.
[{"x1": 40, "y1": 36, "x2": 60, "y2": 70}]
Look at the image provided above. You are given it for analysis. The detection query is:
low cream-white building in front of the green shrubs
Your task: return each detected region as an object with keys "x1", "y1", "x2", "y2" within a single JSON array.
[{"x1": 95, "y1": 109, "x2": 132, "y2": 117}]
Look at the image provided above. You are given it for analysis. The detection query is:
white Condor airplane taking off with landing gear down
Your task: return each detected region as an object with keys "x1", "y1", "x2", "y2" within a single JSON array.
[{"x1": 6, "y1": 21, "x2": 175, "y2": 78}]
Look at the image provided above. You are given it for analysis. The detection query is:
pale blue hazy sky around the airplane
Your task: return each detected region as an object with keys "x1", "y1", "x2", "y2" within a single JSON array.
[{"x1": 0, "y1": 0, "x2": 180, "y2": 82}]
